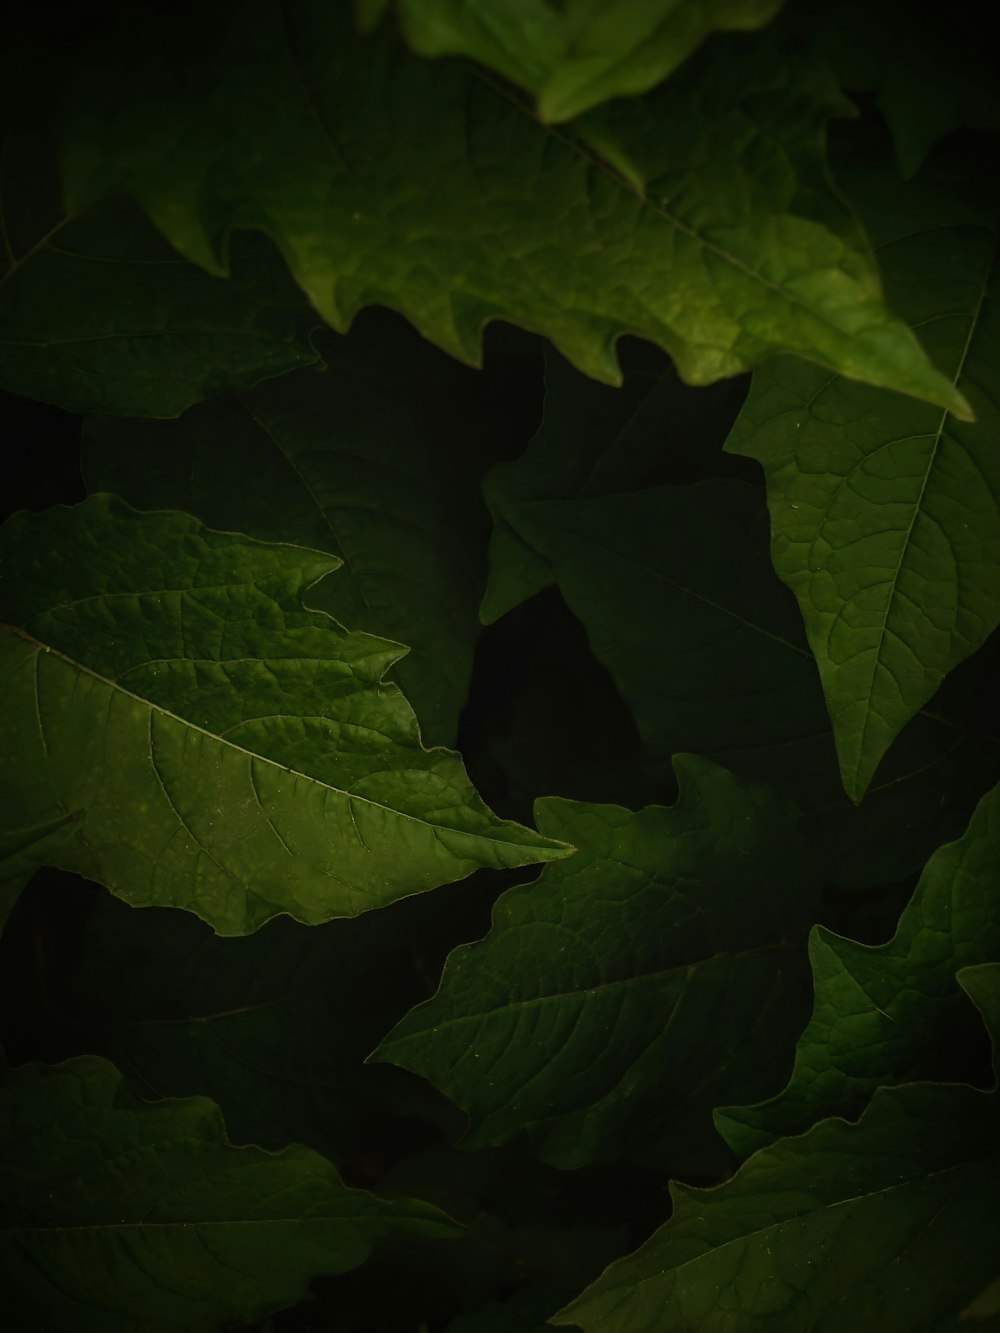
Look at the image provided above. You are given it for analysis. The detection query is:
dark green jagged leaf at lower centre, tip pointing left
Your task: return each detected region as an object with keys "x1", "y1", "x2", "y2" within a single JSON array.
[{"x1": 376, "y1": 756, "x2": 815, "y2": 1170}]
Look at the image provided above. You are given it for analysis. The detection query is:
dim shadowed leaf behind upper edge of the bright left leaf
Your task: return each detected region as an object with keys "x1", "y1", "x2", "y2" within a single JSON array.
[{"x1": 84, "y1": 312, "x2": 504, "y2": 744}]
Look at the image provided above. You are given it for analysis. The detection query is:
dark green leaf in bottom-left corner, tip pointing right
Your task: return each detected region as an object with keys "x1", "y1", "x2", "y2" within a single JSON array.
[{"x1": 0, "y1": 1057, "x2": 460, "y2": 1333}]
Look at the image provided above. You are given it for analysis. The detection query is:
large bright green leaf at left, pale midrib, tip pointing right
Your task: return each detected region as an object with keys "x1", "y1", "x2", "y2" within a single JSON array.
[{"x1": 3, "y1": 496, "x2": 565, "y2": 934}]
